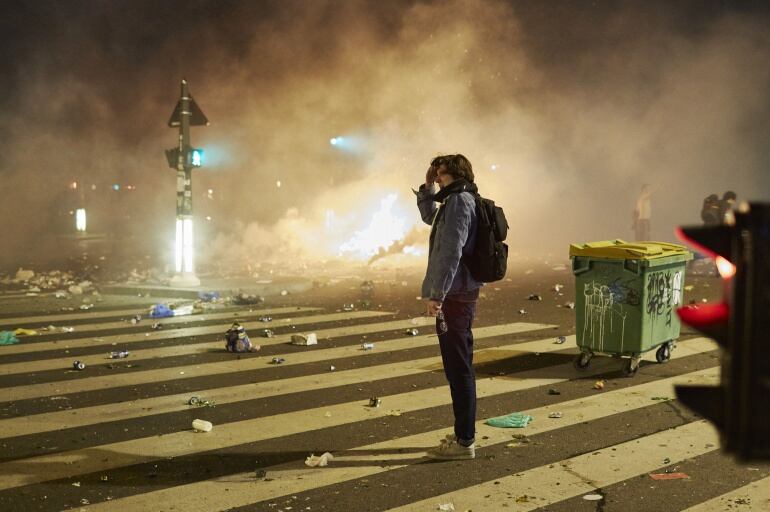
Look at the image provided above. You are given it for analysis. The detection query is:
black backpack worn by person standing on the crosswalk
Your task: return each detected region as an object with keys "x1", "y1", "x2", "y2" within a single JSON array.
[{"x1": 463, "y1": 194, "x2": 508, "y2": 283}]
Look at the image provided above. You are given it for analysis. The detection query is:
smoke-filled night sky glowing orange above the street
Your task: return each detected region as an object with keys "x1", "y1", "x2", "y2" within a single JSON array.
[{"x1": 0, "y1": 0, "x2": 770, "y2": 266}]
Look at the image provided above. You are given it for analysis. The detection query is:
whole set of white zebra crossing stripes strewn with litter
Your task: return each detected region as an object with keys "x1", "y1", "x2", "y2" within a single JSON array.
[{"x1": 0, "y1": 300, "x2": 770, "y2": 512}]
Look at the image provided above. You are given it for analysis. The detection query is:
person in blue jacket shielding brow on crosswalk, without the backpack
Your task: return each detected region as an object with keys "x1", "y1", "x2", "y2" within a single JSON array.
[{"x1": 415, "y1": 154, "x2": 481, "y2": 460}]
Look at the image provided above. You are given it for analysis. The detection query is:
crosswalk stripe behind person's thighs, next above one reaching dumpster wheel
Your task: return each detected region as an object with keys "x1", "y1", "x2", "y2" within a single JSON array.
[{"x1": 3, "y1": 317, "x2": 554, "y2": 401}]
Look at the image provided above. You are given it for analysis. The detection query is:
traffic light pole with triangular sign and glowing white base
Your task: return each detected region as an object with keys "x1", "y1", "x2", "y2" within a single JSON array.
[{"x1": 166, "y1": 80, "x2": 208, "y2": 287}]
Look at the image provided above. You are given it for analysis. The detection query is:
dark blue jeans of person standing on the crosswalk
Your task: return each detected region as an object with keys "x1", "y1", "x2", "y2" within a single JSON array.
[{"x1": 436, "y1": 290, "x2": 479, "y2": 443}]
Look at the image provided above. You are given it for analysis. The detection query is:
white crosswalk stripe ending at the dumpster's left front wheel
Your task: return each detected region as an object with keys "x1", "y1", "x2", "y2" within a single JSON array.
[{"x1": 0, "y1": 332, "x2": 574, "y2": 439}]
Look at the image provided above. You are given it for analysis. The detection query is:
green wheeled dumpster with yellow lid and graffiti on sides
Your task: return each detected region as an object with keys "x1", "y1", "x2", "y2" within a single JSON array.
[{"x1": 569, "y1": 240, "x2": 692, "y2": 377}]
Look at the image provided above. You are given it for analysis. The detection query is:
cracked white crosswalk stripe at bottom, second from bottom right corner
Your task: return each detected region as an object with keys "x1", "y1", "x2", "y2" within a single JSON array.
[{"x1": 390, "y1": 420, "x2": 719, "y2": 512}]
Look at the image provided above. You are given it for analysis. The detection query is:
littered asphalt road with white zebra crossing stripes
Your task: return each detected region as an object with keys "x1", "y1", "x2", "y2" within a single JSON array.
[{"x1": 0, "y1": 263, "x2": 770, "y2": 512}]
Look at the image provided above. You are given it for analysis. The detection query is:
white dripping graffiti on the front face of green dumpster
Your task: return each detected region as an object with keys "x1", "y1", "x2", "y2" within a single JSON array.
[{"x1": 583, "y1": 281, "x2": 627, "y2": 352}]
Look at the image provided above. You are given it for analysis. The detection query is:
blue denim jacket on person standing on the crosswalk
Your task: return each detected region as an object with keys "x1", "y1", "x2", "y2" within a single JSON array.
[{"x1": 415, "y1": 180, "x2": 482, "y2": 302}]
